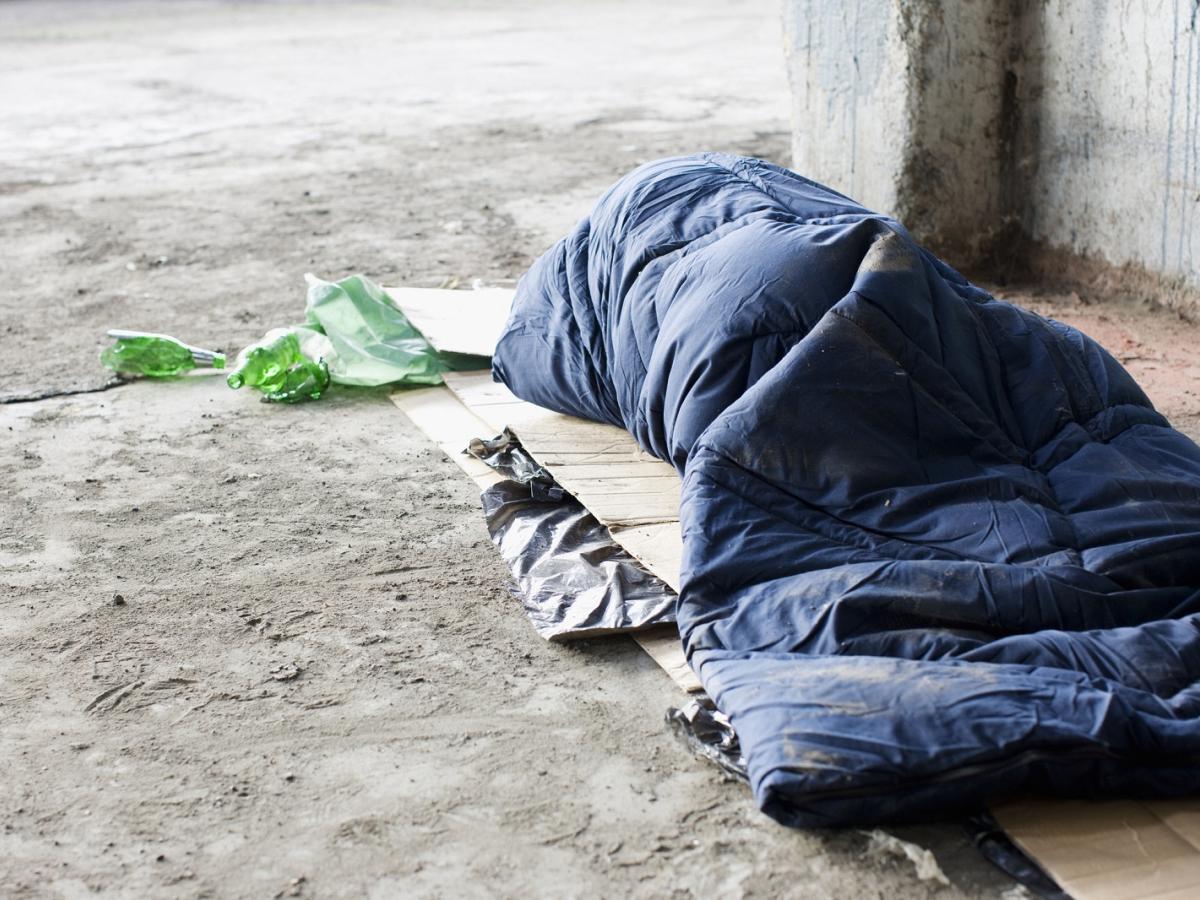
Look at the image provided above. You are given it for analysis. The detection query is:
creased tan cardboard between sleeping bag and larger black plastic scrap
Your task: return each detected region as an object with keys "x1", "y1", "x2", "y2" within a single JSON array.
[{"x1": 445, "y1": 372, "x2": 680, "y2": 528}]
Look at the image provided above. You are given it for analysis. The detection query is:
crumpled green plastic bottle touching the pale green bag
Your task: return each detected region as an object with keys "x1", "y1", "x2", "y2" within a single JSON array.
[{"x1": 226, "y1": 325, "x2": 331, "y2": 403}]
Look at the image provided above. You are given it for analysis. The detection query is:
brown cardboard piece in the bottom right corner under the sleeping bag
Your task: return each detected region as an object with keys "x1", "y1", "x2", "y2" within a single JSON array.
[{"x1": 991, "y1": 799, "x2": 1200, "y2": 900}]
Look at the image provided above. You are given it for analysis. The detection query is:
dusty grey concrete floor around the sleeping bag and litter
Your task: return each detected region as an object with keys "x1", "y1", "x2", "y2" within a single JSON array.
[{"x1": 0, "y1": 0, "x2": 1200, "y2": 898}]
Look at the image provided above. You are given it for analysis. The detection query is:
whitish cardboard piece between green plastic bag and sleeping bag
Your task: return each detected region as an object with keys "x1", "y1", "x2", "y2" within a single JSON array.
[{"x1": 384, "y1": 288, "x2": 515, "y2": 356}]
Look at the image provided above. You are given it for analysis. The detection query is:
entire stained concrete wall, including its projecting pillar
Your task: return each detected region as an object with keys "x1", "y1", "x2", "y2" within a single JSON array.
[{"x1": 785, "y1": 0, "x2": 1200, "y2": 287}]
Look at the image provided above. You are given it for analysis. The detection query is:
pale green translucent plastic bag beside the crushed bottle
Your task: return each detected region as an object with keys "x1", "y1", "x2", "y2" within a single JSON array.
[{"x1": 305, "y1": 275, "x2": 448, "y2": 386}]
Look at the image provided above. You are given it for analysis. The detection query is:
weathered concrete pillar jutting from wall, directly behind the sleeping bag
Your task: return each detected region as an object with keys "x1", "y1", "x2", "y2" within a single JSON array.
[{"x1": 784, "y1": 0, "x2": 1015, "y2": 259}]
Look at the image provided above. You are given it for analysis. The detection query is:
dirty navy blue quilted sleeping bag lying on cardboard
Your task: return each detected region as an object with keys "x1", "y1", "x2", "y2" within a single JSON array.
[{"x1": 493, "y1": 154, "x2": 1200, "y2": 826}]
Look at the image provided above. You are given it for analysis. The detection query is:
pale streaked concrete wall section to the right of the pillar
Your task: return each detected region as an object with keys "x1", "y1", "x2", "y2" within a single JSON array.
[{"x1": 1021, "y1": 0, "x2": 1200, "y2": 283}]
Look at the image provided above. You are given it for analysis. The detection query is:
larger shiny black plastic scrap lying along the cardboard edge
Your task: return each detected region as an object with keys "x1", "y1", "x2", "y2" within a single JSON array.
[{"x1": 467, "y1": 430, "x2": 676, "y2": 641}]
